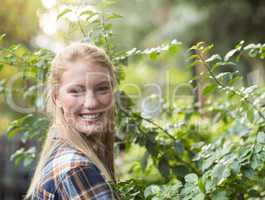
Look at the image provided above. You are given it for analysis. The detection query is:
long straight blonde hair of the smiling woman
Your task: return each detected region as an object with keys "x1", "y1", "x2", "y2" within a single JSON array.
[{"x1": 25, "y1": 43, "x2": 115, "y2": 199}]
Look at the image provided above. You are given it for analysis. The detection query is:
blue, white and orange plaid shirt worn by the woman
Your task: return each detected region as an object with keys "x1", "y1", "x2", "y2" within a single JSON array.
[{"x1": 32, "y1": 143, "x2": 115, "y2": 200}]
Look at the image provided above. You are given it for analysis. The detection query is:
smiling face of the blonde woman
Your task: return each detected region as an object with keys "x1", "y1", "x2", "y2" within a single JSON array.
[{"x1": 54, "y1": 60, "x2": 113, "y2": 135}]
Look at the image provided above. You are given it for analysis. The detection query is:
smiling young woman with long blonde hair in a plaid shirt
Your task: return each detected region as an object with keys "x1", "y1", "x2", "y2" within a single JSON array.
[{"x1": 25, "y1": 43, "x2": 116, "y2": 200}]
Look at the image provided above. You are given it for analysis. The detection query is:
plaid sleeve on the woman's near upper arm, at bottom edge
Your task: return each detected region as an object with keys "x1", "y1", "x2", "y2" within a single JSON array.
[{"x1": 57, "y1": 164, "x2": 115, "y2": 200}]
